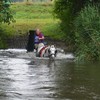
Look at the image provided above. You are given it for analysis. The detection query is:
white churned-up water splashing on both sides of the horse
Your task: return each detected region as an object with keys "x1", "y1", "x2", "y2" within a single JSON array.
[{"x1": 0, "y1": 49, "x2": 74, "y2": 59}]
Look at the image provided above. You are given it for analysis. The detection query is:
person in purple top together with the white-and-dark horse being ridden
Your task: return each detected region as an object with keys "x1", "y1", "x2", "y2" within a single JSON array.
[{"x1": 34, "y1": 29, "x2": 57, "y2": 59}]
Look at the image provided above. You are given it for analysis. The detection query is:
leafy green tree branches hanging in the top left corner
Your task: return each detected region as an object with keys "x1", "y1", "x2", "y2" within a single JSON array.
[{"x1": 0, "y1": 0, "x2": 14, "y2": 24}]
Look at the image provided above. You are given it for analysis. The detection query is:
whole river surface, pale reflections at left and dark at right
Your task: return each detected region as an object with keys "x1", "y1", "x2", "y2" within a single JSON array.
[{"x1": 0, "y1": 49, "x2": 100, "y2": 100}]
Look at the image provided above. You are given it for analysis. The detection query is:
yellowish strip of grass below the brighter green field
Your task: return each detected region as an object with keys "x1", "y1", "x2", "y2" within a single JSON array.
[{"x1": 11, "y1": 19, "x2": 56, "y2": 33}]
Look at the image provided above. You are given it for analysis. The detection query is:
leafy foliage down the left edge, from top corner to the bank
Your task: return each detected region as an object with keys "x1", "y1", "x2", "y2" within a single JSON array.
[{"x1": 0, "y1": 0, "x2": 13, "y2": 48}]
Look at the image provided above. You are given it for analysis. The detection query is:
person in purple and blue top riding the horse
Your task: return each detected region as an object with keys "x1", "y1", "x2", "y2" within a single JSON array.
[{"x1": 34, "y1": 29, "x2": 44, "y2": 50}]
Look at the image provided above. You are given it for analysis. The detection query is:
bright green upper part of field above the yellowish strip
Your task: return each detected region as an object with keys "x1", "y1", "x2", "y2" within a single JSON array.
[{"x1": 11, "y1": 3, "x2": 52, "y2": 19}]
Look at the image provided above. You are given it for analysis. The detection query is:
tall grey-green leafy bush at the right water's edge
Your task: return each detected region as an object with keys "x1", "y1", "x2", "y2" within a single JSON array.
[{"x1": 74, "y1": 5, "x2": 100, "y2": 60}]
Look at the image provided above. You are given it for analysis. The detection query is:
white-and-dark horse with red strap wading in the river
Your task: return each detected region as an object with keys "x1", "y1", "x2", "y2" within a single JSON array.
[{"x1": 36, "y1": 43, "x2": 57, "y2": 59}]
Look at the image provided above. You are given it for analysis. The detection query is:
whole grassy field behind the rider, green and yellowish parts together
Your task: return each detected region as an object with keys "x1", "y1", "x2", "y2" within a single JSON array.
[{"x1": 8, "y1": 3, "x2": 60, "y2": 38}]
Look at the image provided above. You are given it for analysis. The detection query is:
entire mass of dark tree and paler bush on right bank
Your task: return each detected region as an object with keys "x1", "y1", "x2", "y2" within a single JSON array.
[{"x1": 54, "y1": 0, "x2": 100, "y2": 61}]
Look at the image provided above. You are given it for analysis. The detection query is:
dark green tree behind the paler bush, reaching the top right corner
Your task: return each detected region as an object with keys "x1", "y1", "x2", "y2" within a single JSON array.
[{"x1": 53, "y1": 0, "x2": 100, "y2": 45}]
